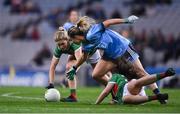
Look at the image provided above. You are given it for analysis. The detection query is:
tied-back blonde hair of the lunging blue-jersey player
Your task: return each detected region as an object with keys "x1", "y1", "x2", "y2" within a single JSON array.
[{"x1": 77, "y1": 16, "x2": 96, "y2": 32}]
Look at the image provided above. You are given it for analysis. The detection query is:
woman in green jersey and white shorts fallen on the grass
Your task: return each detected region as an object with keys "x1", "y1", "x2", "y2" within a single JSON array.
[{"x1": 96, "y1": 68, "x2": 175, "y2": 104}]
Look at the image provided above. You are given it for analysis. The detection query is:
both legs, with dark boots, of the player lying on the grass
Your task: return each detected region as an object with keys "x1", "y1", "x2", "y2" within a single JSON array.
[{"x1": 122, "y1": 73, "x2": 173, "y2": 104}]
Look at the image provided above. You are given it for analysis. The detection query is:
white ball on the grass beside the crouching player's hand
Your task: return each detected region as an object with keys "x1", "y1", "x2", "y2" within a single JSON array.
[{"x1": 44, "y1": 88, "x2": 61, "y2": 102}]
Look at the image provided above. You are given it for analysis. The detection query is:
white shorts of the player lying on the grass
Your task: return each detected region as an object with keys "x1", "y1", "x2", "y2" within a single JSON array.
[{"x1": 123, "y1": 80, "x2": 146, "y2": 97}]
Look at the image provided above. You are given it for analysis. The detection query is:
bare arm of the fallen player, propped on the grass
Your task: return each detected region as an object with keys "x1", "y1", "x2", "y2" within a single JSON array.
[{"x1": 95, "y1": 83, "x2": 114, "y2": 104}]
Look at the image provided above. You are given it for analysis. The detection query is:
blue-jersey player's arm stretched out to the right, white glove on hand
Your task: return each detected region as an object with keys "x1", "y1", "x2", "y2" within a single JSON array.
[{"x1": 103, "y1": 15, "x2": 139, "y2": 27}]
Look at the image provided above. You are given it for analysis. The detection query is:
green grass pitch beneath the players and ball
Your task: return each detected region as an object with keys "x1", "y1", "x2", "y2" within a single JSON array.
[{"x1": 0, "y1": 87, "x2": 180, "y2": 113}]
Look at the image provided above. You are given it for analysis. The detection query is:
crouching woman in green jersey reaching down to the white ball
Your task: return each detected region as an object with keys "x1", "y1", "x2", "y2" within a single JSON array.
[{"x1": 47, "y1": 27, "x2": 108, "y2": 102}]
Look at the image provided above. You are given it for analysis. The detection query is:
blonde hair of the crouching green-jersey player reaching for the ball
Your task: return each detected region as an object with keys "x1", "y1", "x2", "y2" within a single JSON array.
[{"x1": 54, "y1": 27, "x2": 69, "y2": 42}]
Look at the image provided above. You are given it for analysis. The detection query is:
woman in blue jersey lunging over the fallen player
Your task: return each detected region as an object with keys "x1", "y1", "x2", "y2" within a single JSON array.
[{"x1": 67, "y1": 16, "x2": 168, "y2": 104}]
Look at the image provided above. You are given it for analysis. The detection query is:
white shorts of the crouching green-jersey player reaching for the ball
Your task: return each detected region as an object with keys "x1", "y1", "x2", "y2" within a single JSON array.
[{"x1": 86, "y1": 50, "x2": 101, "y2": 64}]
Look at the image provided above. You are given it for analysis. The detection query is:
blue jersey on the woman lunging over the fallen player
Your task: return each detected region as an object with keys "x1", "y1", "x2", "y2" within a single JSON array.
[{"x1": 82, "y1": 23, "x2": 130, "y2": 59}]
